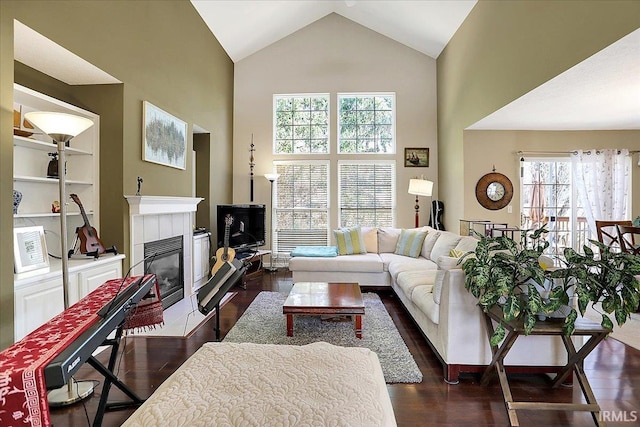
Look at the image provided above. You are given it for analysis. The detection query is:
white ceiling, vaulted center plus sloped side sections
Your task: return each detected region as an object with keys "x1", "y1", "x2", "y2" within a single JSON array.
[{"x1": 14, "y1": 0, "x2": 640, "y2": 130}]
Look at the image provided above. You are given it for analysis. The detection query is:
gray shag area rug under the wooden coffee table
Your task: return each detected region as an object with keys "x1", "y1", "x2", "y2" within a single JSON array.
[{"x1": 223, "y1": 292, "x2": 422, "y2": 383}]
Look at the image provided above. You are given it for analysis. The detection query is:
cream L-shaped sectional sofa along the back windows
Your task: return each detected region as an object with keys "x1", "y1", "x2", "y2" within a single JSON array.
[{"x1": 289, "y1": 227, "x2": 567, "y2": 383}]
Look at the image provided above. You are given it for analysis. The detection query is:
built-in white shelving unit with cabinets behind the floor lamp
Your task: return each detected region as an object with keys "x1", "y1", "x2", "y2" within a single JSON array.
[{"x1": 13, "y1": 84, "x2": 124, "y2": 340}]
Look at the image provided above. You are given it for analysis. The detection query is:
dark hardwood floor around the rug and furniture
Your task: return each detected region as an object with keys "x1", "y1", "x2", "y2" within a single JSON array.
[{"x1": 52, "y1": 269, "x2": 640, "y2": 427}]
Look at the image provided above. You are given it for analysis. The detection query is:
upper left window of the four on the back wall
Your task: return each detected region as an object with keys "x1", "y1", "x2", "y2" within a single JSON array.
[{"x1": 273, "y1": 94, "x2": 329, "y2": 154}]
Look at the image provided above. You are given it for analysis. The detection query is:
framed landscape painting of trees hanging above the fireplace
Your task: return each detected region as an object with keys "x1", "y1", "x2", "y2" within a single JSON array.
[{"x1": 142, "y1": 101, "x2": 187, "y2": 169}]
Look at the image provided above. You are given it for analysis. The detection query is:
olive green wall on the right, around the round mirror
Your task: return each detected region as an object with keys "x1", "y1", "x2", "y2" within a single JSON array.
[{"x1": 437, "y1": 0, "x2": 640, "y2": 229}]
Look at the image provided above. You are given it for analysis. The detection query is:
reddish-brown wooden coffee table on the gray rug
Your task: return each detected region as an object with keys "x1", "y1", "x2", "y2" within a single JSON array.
[{"x1": 282, "y1": 282, "x2": 364, "y2": 338}]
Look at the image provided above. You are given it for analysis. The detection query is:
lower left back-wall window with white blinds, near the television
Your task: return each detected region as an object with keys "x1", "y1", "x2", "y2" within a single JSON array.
[{"x1": 271, "y1": 160, "x2": 329, "y2": 253}]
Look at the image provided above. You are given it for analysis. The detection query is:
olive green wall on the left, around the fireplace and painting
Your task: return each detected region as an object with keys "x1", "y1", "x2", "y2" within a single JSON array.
[{"x1": 0, "y1": 0, "x2": 233, "y2": 348}]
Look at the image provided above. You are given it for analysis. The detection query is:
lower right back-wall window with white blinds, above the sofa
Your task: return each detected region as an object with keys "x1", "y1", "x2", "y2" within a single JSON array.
[{"x1": 338, "y1": 161, "x2": 396, "y2": 227}]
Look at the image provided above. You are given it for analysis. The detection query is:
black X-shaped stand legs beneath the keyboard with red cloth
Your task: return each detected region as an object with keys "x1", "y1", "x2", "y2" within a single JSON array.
[{"x1": 87, "y1": 325, "x2": 145, "y2": 427}]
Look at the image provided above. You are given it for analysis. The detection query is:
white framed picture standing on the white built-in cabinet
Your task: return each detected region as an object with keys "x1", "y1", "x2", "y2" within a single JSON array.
[{"x1": 13, "y1": 225, "x2": 49, "y2": 273}]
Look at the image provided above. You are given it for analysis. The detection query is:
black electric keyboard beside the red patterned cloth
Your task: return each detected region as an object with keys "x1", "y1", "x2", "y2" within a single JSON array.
[{"x1": 44, "y1": 275, "x2": 155, "y2": 390}]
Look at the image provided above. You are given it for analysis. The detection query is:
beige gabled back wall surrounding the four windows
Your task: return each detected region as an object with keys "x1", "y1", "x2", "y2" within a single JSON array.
[{"x1": 233, "y1": 14, "x2": 440, "y2": 244}]
